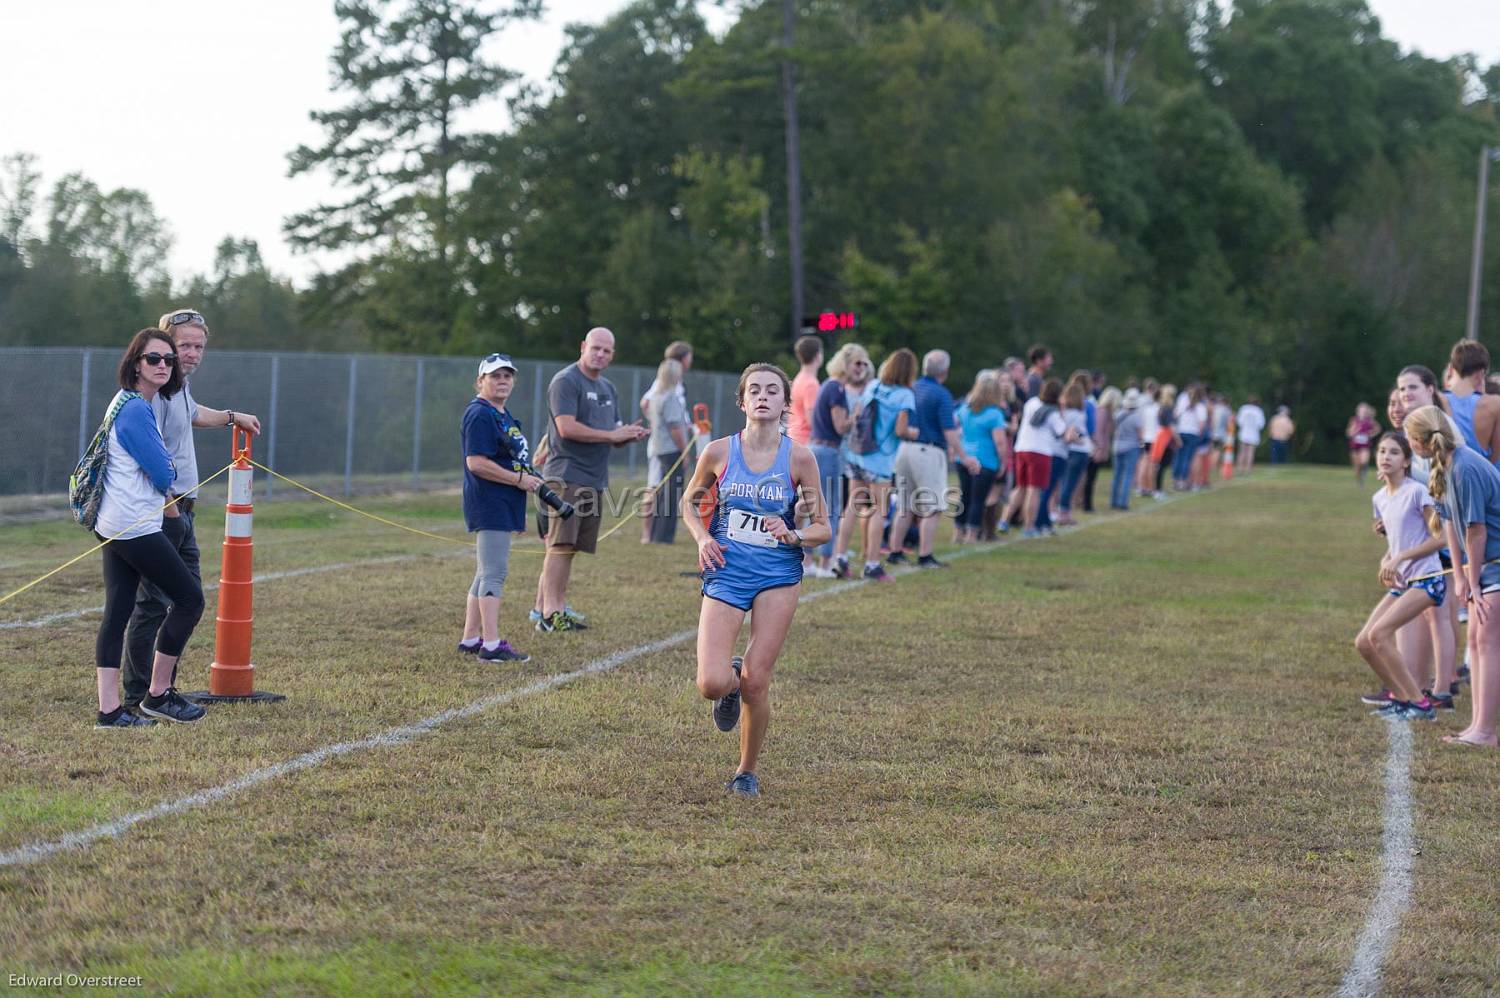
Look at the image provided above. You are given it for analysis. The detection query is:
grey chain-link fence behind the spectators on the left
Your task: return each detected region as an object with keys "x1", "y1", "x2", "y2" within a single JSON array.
[{"x1": 0, "y1": 344, "x2": 740, "y2": 507}]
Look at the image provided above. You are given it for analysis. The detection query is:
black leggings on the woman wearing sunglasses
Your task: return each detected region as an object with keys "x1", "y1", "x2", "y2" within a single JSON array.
[{"x1": 95, "y1": 530, "x2": 203, "y2": 669}]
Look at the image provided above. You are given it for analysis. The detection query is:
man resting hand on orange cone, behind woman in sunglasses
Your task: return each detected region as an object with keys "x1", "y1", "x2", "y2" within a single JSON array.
[{"x1": 123, "y1": 309, "x2": 261, "y2": 710}]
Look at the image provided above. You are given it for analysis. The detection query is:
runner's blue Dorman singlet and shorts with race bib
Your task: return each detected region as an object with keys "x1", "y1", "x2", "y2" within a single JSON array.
[{"x1": 704, "y1": 434, "x2": 803, "y2": 611}]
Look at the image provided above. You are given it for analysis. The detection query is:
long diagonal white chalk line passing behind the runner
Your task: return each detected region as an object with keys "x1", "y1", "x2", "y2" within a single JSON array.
[{"x1": 0, "y1": 486, "x2": 1212, "y2": 867}]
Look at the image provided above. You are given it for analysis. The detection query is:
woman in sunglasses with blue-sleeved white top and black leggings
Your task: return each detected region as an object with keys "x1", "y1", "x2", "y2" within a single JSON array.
[{"x1": 95, "y1": 329, "x2": 204, "y2": 728}]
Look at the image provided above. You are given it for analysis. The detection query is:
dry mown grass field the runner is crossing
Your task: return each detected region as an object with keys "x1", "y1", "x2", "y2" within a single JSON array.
[{"x1": 0, "y1": 468, "x2": 1500, "y2": 995}]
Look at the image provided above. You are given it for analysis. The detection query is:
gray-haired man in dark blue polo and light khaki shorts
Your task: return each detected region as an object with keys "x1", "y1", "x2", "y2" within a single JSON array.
[{"x1": 887, "y1": 350, "x2": 980, "y2": 569}]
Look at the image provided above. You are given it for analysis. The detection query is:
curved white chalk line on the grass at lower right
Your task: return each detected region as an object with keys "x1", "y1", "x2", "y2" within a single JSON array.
[{"x1": 1338, "y1": 720, "x2": 1416, "y2": 998}]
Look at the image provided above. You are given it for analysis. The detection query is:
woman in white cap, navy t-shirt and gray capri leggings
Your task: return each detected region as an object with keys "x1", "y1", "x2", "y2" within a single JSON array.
[{"x1": 459, "y1": 354, "x2": 542, "y2": 662}]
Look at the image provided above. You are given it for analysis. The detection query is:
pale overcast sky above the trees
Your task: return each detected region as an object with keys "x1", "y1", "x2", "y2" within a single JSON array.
[{"x1": 0, "y1": 0, "x2": 1500, "y2": 282}]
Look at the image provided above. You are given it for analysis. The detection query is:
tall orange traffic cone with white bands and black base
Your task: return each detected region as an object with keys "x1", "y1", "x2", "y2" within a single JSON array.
[{"x1": 192, "y1": 426, "x2": 287, "y2": 702}]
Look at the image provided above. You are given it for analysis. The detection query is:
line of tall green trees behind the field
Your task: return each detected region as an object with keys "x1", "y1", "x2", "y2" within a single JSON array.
[{"x1": 0, "y1": 0, "x2": 1500, "y2": 455}]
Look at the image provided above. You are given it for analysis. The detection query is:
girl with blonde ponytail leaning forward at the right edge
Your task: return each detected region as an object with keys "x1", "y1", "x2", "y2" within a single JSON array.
[{"x1": 1404, "y1": 405, "x2": 1500, "y2": 747}]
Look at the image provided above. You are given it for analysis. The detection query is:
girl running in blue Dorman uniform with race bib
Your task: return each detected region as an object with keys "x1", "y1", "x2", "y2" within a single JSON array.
[{"x1": 683, "y1": 363, "x2": 833, "y2": 797}]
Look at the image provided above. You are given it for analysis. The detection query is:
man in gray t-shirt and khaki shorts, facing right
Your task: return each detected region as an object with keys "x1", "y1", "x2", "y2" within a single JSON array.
[{"x1": 537, "y1": 326, "x2": 650, "y2": 633}]
